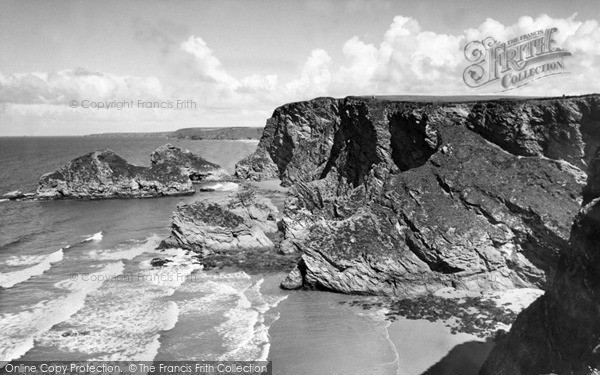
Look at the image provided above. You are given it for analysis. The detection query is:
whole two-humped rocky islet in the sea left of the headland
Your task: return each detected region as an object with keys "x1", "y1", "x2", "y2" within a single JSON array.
[{"x1": 37, "y1": 145, "x2": 226, "y2": 199}]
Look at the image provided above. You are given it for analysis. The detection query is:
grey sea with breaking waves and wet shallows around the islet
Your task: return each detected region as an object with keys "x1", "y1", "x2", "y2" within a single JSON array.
[{"x1": 0, "y1": 136, "x2": 482, "y2": 375}]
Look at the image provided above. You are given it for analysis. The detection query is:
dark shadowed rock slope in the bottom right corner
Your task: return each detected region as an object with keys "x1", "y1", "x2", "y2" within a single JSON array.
[{"x1": 480, "y1": 152, "x2": 600, "y2": 375}]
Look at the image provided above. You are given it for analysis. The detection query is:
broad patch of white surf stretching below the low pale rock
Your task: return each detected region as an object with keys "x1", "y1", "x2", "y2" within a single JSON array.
[{"x1": 33, "y1": 251, "x2": 201, "y2": 361}]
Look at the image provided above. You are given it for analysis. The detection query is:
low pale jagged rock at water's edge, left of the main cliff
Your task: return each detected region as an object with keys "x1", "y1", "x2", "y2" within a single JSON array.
[{"x1": 162, "y1": 201, "x2": 274, "y2": 255}]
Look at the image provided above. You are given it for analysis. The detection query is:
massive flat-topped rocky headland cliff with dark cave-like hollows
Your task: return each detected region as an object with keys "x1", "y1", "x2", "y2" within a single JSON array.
[{"x1": 236, "y1": 95, "x2": 600, "y2": 295}]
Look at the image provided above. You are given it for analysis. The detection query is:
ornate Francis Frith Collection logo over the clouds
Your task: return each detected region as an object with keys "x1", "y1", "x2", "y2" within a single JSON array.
[{"x1": 463, "y1": 27, "x2": 571, "y2": 91}]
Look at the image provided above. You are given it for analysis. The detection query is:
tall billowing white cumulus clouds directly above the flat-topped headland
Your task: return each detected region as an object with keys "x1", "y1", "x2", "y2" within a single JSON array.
[{"x1": 288, "y1": 14, "x2": 600, "y2": 99}]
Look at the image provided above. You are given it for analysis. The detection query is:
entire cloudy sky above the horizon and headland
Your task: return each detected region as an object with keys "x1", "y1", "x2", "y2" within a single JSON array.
[{"x1": 0, "y1": 0, "x2": 600, "y2": 136}]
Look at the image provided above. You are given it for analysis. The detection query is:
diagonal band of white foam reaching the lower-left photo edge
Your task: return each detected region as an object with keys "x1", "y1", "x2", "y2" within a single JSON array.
[{"x1": 0, "y1": 262, "x2": 124, "y2": 361}]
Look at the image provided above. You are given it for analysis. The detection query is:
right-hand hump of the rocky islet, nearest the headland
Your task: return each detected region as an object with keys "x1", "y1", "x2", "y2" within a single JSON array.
[{"x1": 150, "y1": 143, "x2": 229, "y2": 182}]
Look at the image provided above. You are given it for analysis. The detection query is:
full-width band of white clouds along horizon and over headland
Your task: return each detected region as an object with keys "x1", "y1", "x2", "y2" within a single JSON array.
[{"x1": 0, "y1": 13, "x2": 600, "y2": 135}]
